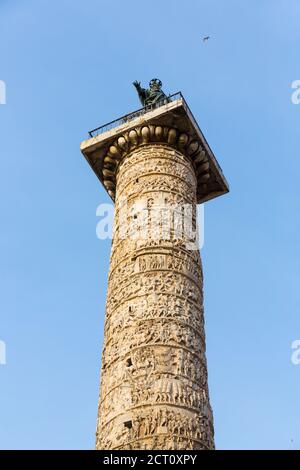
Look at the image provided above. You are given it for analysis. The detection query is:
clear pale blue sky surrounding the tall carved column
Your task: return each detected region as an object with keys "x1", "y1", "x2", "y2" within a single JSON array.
[{"x1": 0, "y1": 0, "x2": 300, "y2": 449}]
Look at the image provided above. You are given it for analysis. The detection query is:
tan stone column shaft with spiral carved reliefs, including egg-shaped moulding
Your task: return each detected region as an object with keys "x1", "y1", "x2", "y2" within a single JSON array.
[{"x1": 84, "y1": 98, "x2": 229, "y2": 450}]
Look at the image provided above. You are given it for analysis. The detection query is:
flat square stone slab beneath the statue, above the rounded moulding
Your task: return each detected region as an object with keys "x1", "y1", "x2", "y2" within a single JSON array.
[{"x1": 80, "y1": 93, "x2": 229, "y2": 204}]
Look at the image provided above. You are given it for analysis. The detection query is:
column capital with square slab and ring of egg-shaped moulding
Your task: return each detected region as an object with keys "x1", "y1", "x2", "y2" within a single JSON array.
[{"x1": 80, "y1": 97, "x2": 229, "y2": 204}]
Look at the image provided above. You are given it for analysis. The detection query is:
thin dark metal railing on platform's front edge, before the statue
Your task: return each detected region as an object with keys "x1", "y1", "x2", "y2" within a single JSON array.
[{"x1": 89, "y1": 91, "x2": 187, "y2": 137}]
